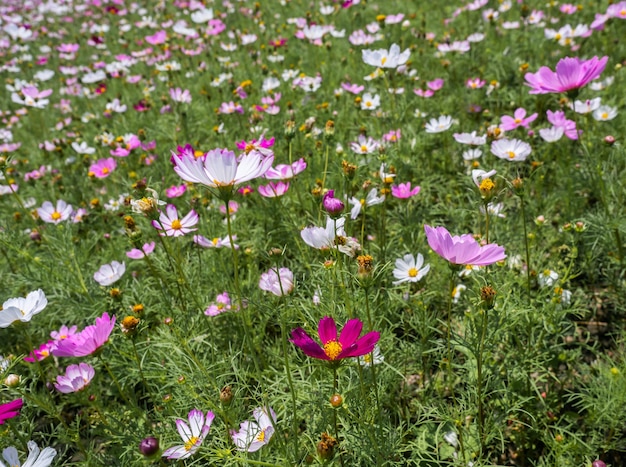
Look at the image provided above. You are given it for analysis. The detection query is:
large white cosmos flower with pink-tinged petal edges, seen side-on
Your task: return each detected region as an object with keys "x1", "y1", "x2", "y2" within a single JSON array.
[{"x1": 170, "y1": 148, "x2": 274, "y2": 189}]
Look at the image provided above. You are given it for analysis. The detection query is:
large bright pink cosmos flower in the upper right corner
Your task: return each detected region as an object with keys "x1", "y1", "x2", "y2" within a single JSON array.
[{"x1": 524, "y1": 57, "x2": 609, "y2": 94}]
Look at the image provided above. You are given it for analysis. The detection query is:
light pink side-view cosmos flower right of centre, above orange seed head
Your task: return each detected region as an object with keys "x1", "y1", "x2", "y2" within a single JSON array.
[{"x1": 424, "y1": 225, "x2": 506, "y2": 266}]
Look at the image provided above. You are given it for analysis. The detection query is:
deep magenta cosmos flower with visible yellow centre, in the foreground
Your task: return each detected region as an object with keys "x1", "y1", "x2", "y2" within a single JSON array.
[{"x1": 290, "y1": 316, "x2": 380, "y2": 361}]
